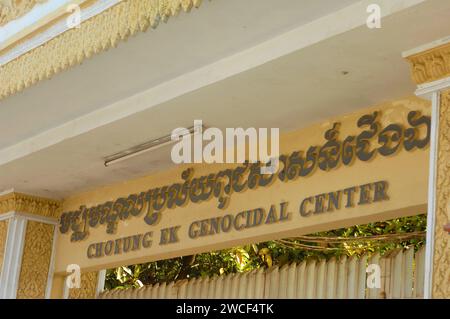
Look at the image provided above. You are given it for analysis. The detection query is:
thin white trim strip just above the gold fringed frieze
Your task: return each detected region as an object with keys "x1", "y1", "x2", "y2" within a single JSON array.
[{"x1": 0, "y1": 0, "x2": 121, "y2": 66}]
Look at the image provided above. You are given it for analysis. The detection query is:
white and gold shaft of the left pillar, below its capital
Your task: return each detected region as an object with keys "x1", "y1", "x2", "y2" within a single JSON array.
[{"x1": 0, "y1": 211, "x2": 57, "y2": 298}]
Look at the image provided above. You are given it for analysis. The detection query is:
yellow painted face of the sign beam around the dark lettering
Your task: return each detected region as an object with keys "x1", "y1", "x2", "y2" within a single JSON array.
[{"x1": 56, "y1": 97, "x2": 430, "y2": 274}]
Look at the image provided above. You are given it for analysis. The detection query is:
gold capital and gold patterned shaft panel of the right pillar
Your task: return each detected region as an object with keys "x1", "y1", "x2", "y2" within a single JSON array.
[{"x1": 407, "y1": 44, "x2": 450, "y2": 298}]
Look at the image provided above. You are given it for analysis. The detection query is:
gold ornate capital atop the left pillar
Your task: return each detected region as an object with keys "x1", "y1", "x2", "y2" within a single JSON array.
[{"x1": 0, "y1": 193, "x2": 61, "y2": 218}]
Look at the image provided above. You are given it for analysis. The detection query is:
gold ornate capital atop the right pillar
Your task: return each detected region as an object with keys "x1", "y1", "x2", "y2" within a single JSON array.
[{"x1": 407, "y1": 43, "x2": 450, "y2": 84}]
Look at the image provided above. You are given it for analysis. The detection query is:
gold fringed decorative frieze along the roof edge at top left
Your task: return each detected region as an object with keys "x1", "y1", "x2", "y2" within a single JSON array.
[{"x1": 0, "y1": 0, "x2": 206, "y2": 99}]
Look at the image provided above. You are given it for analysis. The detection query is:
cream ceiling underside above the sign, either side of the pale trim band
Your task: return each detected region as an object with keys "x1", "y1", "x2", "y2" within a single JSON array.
[{"x1": 0, "y1": 0, "x2": 450, "y2": 198}]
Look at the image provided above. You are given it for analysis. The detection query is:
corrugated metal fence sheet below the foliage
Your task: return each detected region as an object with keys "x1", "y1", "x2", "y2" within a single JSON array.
[{"x1": 98, "y1": 248, "x2": 425, "y2": 299}]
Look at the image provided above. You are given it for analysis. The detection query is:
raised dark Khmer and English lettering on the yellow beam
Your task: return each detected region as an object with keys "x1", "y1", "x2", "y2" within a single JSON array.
[{"x1": 59, "y1": 111, "x2": 431, "y2": 260}]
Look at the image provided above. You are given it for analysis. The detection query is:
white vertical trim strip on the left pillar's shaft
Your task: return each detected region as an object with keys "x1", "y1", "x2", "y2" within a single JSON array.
[{"x1": 0, "y1": 215, "x2": 27, "y2": 299}]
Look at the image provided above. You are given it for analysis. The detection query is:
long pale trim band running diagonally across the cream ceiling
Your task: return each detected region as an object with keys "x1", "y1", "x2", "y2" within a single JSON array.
[{"x1": 0, "y1": 0, "x2": 425, "y2": 169}]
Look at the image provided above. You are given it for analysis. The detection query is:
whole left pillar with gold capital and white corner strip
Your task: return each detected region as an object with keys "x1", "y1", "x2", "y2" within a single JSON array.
[{"x1": 0, "y1": 192, "x2": 60, "y2": 299}]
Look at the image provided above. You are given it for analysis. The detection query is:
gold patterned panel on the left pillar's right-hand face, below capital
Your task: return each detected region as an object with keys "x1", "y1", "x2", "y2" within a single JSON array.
[{"x1": 17, "y1": 221, "x2": 54, "y2": 299}]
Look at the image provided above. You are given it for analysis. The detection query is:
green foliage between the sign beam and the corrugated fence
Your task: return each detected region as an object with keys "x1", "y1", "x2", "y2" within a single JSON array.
[{"x1": 105, "y1": 215, "x2": 426, "y2": 290}]
